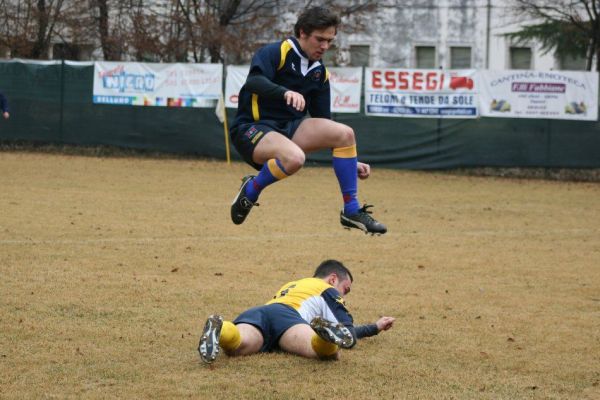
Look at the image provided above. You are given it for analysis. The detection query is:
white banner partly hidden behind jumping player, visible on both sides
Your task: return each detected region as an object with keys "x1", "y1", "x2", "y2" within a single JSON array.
[{"x1": 225, "y1": 65, "x2": 362, "y2": 113}]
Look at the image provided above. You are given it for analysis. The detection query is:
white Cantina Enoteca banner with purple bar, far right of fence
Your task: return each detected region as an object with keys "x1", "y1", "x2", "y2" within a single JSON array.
[{"x1": 480, "y1": 70, "x2": 598, "y2": 121}]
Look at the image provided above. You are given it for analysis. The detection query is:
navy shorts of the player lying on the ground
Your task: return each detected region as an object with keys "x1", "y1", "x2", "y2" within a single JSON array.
[{"x1": 233, "y1": 303, "x2": 308, "y2": 353}]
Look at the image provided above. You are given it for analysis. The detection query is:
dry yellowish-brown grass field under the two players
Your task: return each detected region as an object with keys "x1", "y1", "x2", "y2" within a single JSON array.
[{"x1": 0, "y1": 152, "x2": 600, "y2": 399}]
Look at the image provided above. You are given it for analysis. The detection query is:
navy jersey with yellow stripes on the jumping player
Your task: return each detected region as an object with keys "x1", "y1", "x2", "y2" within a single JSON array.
[{"x1": 233, "y1": 37, "x2": 331, "y2": 126}]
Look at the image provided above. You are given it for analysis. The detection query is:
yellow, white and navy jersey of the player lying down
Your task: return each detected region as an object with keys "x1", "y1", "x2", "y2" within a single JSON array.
[{"x1": 267, "y1": 278, "x2": 353, "y2": 327}]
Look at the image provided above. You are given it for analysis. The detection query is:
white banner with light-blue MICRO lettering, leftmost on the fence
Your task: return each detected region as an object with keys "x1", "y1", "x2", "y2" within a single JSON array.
[{"x1": 93, "y1": 62, "x2": 223, "y2": 107}]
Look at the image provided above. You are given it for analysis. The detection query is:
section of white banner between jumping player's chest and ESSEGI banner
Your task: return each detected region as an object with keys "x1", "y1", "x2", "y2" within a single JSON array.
[{"x1": 327, "y1": 67, "x2": 362, "y2": 113}]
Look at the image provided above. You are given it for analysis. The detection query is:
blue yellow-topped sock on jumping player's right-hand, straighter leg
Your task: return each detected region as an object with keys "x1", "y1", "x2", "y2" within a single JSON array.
[{"x1": 333, "y1": 144, "x2": 360, "y2": 215}]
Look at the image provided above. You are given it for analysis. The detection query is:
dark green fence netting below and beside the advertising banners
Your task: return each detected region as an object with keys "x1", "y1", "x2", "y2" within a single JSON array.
[{"x1": 0, "y1": 61, "x2": 600, "y2": 169}]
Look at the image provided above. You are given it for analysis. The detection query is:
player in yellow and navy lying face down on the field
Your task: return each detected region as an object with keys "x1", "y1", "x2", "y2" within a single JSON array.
[{"x1": 198, "y1": 260, "x2": 395, "y2": 363}]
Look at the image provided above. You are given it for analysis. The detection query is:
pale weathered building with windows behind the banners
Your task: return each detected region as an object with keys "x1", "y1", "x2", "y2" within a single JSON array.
[{"x1": 316, "y1": 0, "x2": 585, "y2": 70}]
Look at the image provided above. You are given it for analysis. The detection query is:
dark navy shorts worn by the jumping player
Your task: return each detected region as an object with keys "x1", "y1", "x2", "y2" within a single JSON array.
[{"x1": 229, "y1": 118, "x2": 304, "y2": 170}]
